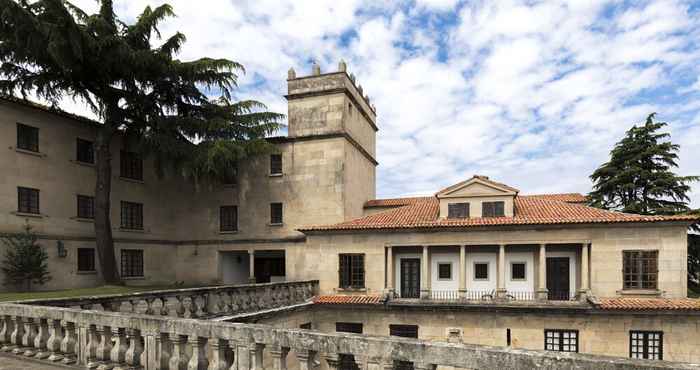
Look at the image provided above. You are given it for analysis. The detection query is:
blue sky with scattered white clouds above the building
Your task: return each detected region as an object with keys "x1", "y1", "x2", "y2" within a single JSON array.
[{"x1": 62, "y1": 0, "x2": 700, "y2": 207}]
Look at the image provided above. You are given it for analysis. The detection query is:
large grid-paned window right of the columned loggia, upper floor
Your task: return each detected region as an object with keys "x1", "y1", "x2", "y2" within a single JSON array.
[{"x1": 622, "y1": 251, "x2": 659, "y2": 289}]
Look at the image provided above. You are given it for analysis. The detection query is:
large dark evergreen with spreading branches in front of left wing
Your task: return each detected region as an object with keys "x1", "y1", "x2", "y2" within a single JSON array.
[{"x1": 0, "y1": 0, "x2": 282, "y2": 284}]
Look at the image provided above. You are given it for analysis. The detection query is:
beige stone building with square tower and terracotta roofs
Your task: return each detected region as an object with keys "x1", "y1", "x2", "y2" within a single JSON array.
[{"x1": 0, "y1": 63, "x2": 700, "y2": 361}]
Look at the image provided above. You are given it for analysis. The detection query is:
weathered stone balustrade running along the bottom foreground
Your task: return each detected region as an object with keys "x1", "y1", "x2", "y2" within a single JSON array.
[{"x1": 0, "y1": 303, "x2": 700, "y2": 370}]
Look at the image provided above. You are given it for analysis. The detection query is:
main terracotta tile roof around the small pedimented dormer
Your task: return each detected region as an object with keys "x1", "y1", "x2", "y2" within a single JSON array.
[{"x1": 299, "y1": 194, "x2": 700, "y2": 231}]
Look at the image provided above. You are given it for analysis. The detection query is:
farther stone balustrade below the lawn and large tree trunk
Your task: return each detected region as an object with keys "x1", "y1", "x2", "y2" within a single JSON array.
[{"x1": 22, "y1": 280, "x2": 318, "y2": 318}]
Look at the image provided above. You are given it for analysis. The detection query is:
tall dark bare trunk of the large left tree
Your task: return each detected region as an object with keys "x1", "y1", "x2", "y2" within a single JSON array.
[{"x1": 95, "y1": 125, "x2": 121, "y2": 284}]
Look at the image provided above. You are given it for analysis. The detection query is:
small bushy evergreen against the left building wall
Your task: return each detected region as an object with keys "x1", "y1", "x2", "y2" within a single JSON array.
[{"x1": 1, "y1": 225, "x2": 51, "y2": 291}]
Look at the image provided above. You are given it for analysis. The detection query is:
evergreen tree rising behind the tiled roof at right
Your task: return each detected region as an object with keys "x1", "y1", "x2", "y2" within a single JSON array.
[{"x1": 589, "y1": 113, "x2": 699, "y2": 215}]
